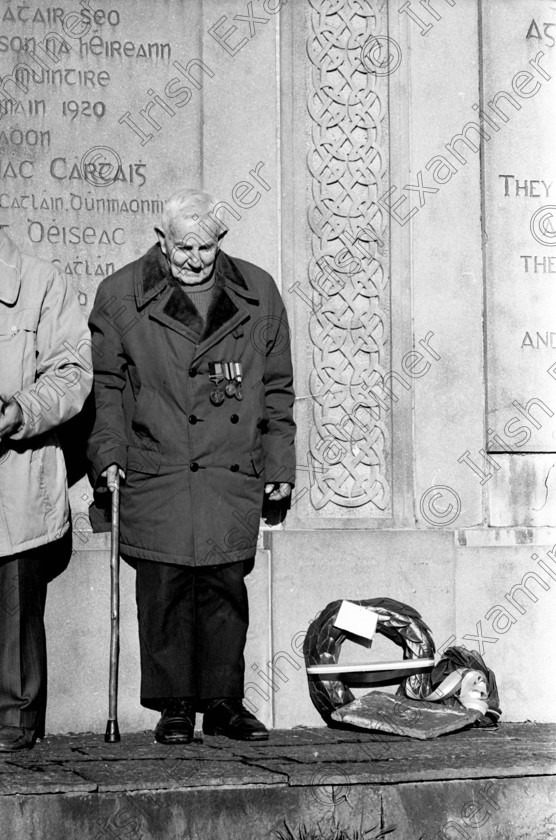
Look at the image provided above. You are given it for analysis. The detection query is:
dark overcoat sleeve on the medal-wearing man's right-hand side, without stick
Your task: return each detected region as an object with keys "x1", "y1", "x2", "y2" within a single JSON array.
[{"x1": 259, "y1": 281, "x2": 296, "y2": 485}]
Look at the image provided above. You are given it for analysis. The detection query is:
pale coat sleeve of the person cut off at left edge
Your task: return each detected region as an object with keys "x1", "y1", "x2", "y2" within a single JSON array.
[{"x1": 11, "y1": 269, "x2": 93, "y2": 440}]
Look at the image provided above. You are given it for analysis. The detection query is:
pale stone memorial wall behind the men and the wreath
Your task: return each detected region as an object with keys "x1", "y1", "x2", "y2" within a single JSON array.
[{"x1": 0, "y1": 0, "x2": 556, "y2": 731}]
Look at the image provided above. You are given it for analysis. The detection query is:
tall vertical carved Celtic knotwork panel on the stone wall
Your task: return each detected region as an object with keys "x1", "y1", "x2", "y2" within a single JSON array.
[{"x1": 307, "y1": 0, "x2": 391, "y2": 517}]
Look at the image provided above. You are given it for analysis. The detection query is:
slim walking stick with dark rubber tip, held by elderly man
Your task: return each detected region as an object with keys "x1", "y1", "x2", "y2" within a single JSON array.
[{"x1": 104, "y1": 469, "x2": 120, "y2": 744}]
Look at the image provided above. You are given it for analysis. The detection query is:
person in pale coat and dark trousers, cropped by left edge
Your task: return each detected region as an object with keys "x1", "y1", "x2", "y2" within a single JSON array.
[{"x1": 0, "y1": 230, "x2": 92, "y2": 752}]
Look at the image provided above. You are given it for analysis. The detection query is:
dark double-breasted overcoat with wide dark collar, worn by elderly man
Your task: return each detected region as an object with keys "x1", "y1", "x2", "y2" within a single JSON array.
[{"x1": 88, "y1": 245, "x2": 295, "y2": 566}]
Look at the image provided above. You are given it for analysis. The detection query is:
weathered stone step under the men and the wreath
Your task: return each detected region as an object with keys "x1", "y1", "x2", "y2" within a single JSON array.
[{"x1": 0, "y1": 724, "x2": 556, "y2": 840}]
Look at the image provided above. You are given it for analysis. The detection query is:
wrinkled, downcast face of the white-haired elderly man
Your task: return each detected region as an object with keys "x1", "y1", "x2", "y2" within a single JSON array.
[{"x1": 156, "y1": 220, "x2": 219, "y2": 286}]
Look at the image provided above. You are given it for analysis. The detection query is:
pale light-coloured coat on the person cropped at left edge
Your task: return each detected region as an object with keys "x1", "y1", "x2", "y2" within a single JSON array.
[{"x1": 0, "y1": 230, "x2": 92, "y2": 557}]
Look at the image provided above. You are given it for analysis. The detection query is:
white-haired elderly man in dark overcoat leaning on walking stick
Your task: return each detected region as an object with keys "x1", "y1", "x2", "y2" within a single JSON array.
[{"x1": 89, "y1": 190, "x2": 295, "y2": 744}]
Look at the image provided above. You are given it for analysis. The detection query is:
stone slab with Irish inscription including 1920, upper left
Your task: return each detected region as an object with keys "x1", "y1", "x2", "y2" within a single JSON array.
[{"x1": 0, "y1": 0, "x2": 206, "y2": 311}]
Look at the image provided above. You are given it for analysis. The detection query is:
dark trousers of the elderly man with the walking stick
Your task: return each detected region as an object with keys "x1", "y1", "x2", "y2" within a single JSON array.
[{"x1": 133, "y1": 560, "x2": 253, "y2": 709}]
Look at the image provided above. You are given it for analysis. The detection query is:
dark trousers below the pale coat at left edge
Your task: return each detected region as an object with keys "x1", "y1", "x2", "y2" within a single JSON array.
[{"x1": 0, "y1": 533, "x2": 71, "y2": 737}]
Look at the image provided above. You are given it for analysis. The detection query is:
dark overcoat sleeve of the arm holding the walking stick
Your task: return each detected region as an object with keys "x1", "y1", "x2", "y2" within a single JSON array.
[{"x1": 87, "y1": 283, "x2": 127, "y2": 487}]
